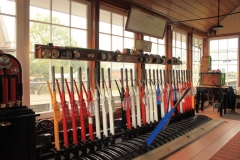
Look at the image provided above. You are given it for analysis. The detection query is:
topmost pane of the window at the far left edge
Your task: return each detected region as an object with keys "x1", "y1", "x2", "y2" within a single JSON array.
[{"x1": 0, "y1": 0, "x2": 16, "y2": 15}]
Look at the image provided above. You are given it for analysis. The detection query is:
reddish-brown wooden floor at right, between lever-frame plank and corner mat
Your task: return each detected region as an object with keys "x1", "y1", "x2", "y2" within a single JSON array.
[{"x1": 164, "y1": 107, "x2": 240, "y2": 160}]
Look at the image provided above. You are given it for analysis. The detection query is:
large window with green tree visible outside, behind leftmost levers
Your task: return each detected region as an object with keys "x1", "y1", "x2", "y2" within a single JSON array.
[{"x1": 29, "y1": 0, "x2": 90, "y2": 112}]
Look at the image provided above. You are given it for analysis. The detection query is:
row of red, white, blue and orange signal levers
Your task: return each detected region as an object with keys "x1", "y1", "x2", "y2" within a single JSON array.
[{"x1": 38, "y1": 66, "x2": 194, "y2": 159}]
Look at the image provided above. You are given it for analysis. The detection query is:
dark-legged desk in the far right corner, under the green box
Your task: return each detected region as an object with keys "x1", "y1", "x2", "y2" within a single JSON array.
[{"x1": 195, "y1": 85, "x2": 228, "y2": 116}]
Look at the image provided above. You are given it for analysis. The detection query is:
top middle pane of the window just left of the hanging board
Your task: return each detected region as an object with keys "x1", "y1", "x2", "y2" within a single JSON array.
[{"x1": 112, "y1": 14, "x2": 123, "y2": 36}]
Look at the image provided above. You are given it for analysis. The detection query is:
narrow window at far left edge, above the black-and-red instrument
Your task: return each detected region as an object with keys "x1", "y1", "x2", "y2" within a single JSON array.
[{"x1": 0, "y1": 0, "x2": 16, "y2": 56}]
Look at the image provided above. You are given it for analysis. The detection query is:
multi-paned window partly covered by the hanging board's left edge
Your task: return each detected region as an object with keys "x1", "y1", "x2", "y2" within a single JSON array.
[{"x1": 99, "y1": 6, "x2": 135, "y2": 97}]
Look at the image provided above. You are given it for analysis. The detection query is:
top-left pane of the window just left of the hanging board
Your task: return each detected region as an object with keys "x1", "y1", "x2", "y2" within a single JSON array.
[{"x1": 99, "y1": 10, "x2": 111, "y2": 33}]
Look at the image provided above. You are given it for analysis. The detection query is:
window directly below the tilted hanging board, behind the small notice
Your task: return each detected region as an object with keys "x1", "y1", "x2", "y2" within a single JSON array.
[{"x1": 143, "y1": 36, "x2": 165, "y2": 70}]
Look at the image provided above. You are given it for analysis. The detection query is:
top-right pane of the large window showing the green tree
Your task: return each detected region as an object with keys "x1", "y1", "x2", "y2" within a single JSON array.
[{"x1": 71, "y1": 2, "x2": 87, "y2": 29}]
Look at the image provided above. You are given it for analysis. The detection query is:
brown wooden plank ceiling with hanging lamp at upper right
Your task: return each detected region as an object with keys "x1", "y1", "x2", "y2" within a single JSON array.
[{"x1": 131, "y1": 0, "x2": 240, "y2": 32}]
